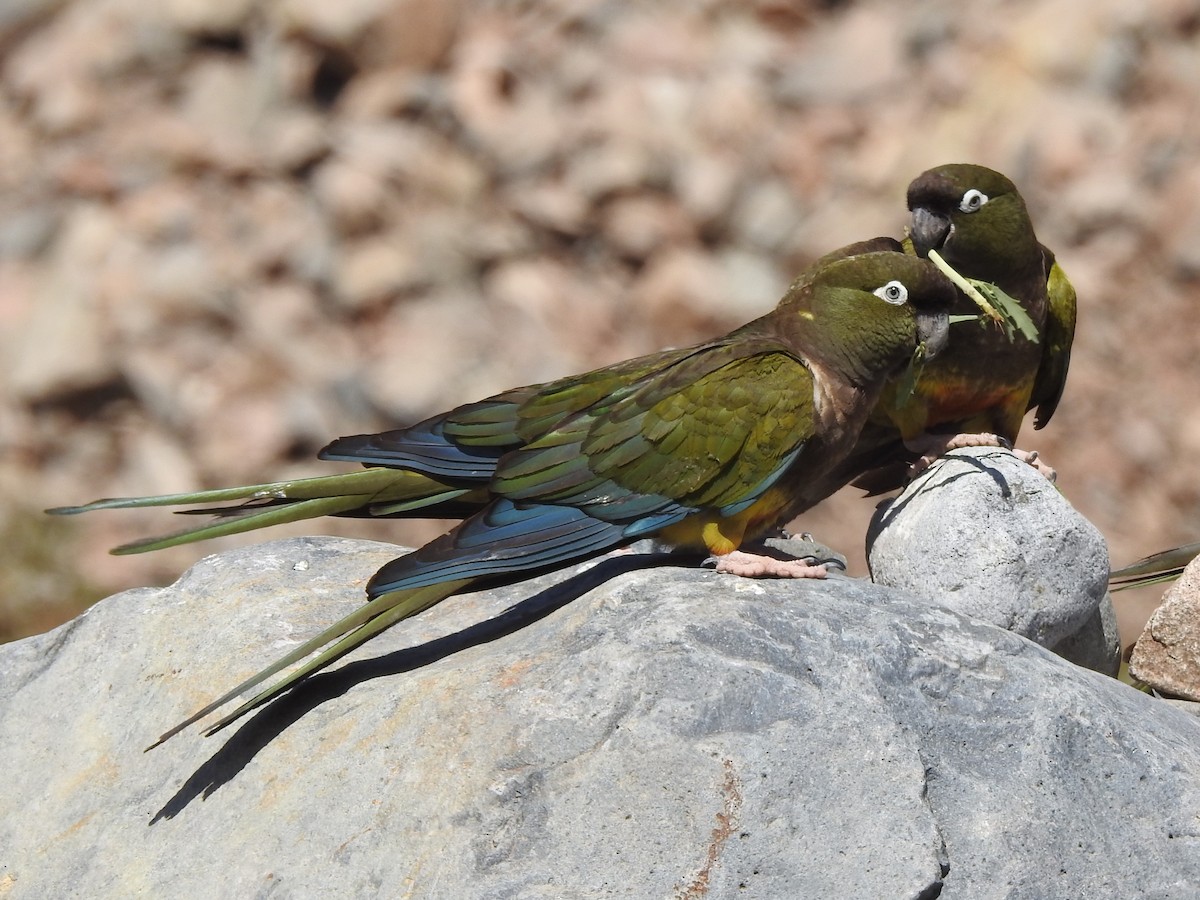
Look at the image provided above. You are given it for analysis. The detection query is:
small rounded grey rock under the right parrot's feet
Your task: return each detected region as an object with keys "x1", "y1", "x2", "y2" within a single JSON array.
[{"x1": 866, "y1": 448, "x2": 1121, "y2": 674}]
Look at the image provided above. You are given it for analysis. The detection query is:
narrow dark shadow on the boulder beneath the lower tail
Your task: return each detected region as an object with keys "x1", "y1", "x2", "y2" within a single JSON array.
[{"x1": 149, "y1": 552, "x2": 686, "y2": 824}]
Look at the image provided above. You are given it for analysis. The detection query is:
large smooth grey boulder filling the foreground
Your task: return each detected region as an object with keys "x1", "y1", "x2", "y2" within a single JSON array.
[{"x1": 0, "y1": 538, "x2": 1200, "y2": 900}]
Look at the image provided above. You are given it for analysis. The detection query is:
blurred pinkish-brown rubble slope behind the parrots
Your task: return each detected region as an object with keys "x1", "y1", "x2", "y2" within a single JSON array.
[{"x1": 0, "y1": 0, "x2": 1200, "y2": 638}]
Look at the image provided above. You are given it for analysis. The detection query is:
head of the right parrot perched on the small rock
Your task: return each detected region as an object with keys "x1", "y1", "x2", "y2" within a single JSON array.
[{"x1": 908, "y1": 163, "x2": 1037, "y2": 281}]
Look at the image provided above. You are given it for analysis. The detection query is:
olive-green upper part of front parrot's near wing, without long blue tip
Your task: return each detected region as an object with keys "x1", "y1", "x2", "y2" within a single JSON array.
[{"x1": 492, "y1": 332, "x2": 814, "y2": 520}]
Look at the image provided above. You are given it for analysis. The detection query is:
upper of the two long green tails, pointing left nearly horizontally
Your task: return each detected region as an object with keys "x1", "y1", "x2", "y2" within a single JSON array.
[{"x1": 47, "y1": 467, "x2": 486, "y2": 554}]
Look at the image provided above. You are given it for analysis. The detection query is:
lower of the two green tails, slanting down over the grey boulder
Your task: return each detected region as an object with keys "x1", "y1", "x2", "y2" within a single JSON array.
[{"x1": 146, "y1": 578, "x2": 473, "y2": 750}]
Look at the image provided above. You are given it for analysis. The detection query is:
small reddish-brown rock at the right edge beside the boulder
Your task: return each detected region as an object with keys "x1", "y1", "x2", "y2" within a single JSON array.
[{"x1": 1129, "y1": 558, "x2": 1200, "y2": 701}]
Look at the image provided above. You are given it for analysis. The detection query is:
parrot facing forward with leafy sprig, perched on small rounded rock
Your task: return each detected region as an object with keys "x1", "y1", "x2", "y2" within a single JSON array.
[{"x1": 840, "y1": 163, "x2": 1075, "y2": 493}]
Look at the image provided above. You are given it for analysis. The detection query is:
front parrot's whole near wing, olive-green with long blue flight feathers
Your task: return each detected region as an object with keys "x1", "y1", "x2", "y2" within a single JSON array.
[{"x1": 367, "y1": 338, "x2": 814, "y2": 596}]
